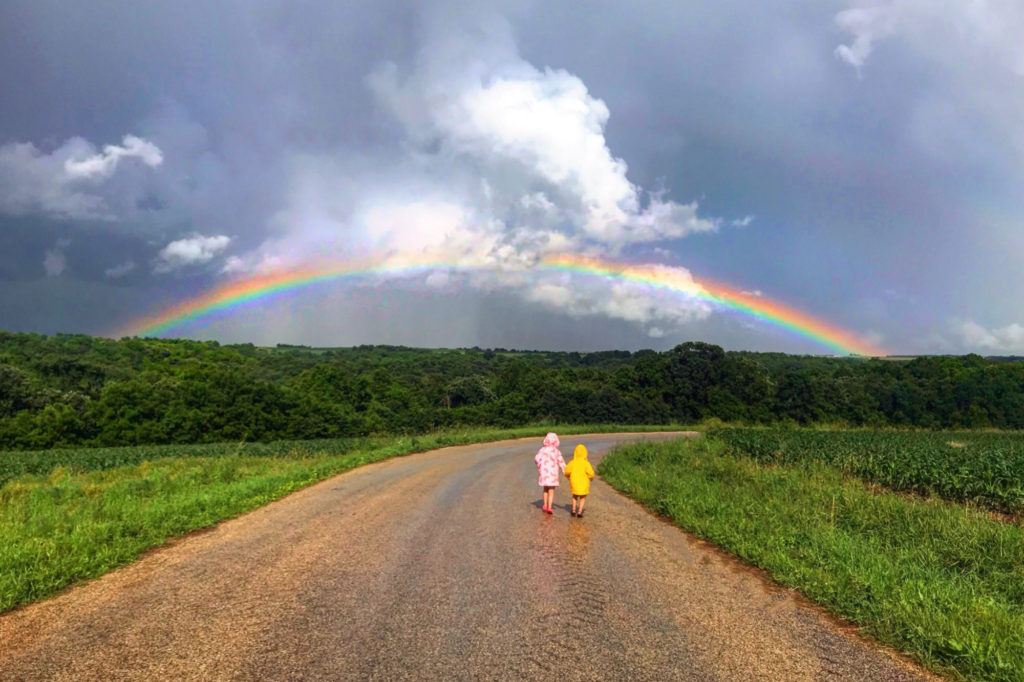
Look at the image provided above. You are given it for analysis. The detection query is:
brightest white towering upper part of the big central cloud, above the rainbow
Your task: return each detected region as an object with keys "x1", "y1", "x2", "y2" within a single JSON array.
[{"x1": 369, "y1": 23, "x2": 719, "y2": 251}]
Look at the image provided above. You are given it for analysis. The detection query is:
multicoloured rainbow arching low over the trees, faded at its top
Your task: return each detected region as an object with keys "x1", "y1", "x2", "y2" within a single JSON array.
[{"x1": 109, "y1": 254, "x2": 886, "y2": 355}]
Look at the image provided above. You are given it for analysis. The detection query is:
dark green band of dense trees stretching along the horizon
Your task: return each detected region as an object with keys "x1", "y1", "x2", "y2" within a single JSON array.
[{"x1": 0, "y1": 332, "x2": 1024, "y2": 450}]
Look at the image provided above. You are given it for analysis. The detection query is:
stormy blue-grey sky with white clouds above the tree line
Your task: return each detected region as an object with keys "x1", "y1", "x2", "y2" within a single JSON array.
[{"x1": 0, "y1": 0, "x2": 1024, "y2": 354}]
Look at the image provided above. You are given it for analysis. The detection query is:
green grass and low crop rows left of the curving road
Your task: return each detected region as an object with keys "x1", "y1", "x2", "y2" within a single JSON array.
[{"x1": 0, "y1": 425, "x2": 678, "y2": 612}]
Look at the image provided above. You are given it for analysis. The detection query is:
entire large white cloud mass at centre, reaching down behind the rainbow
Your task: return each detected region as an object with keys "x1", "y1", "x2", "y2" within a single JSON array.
[{"x1": 225, "y1": 17, "x2": 721, "y2": 333}]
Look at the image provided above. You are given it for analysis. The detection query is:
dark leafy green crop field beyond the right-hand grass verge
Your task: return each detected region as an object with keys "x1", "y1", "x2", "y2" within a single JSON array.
[{"x1": 710, "y1": 428, "x2": 1024, "y2": 513}]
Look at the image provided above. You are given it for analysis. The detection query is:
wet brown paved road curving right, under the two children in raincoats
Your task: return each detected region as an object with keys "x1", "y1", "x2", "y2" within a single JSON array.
[{"x1": 0, "y1": 434, "x2": 929, "y2": 682}]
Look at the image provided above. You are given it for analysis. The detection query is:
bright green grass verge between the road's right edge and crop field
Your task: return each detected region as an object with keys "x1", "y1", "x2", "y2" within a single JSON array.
[{"x1": 599, "y1": 438, "x2": 1024, "y2": 681}]
